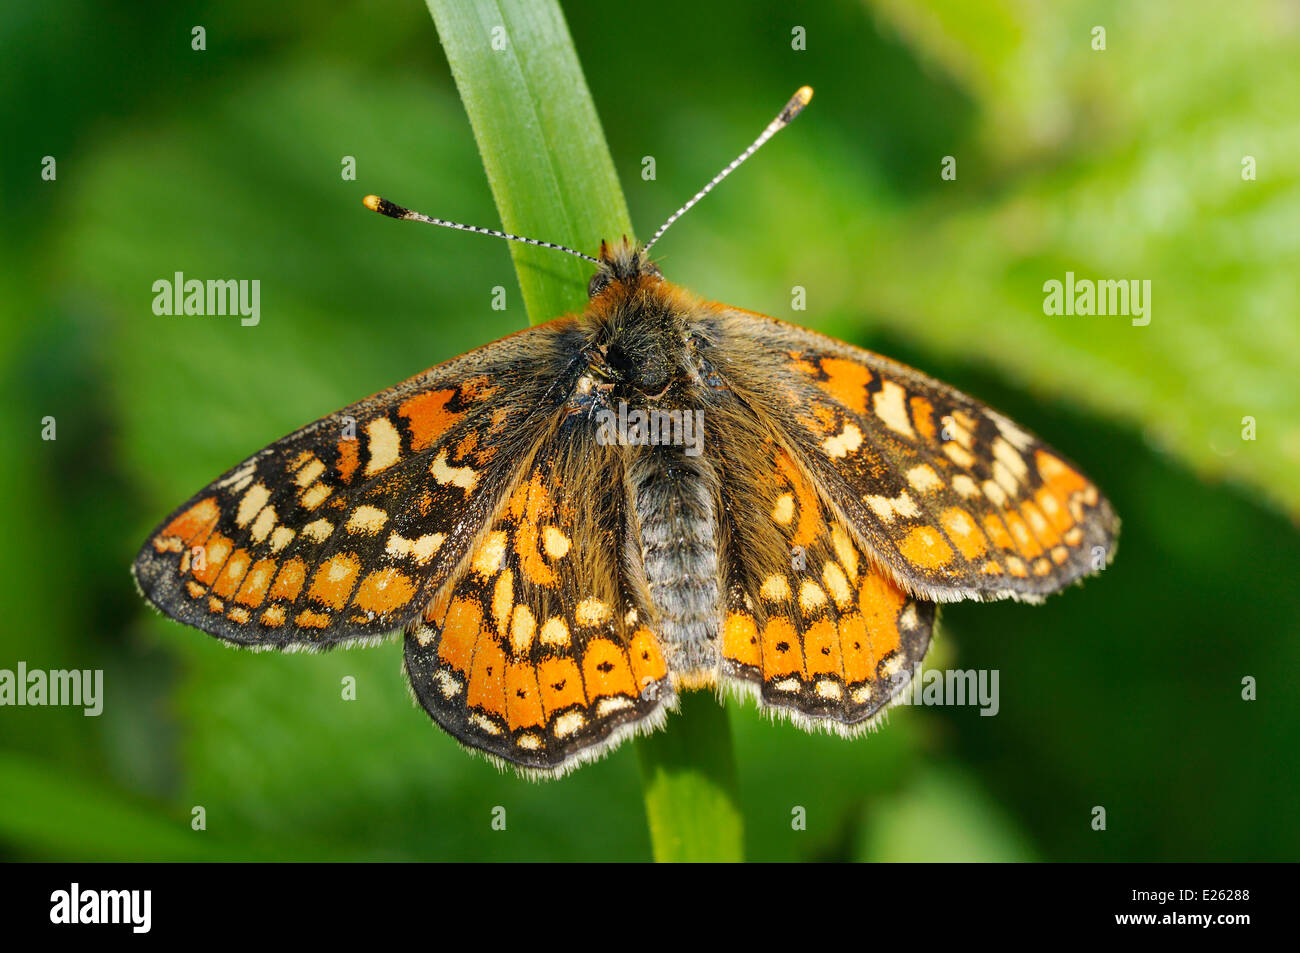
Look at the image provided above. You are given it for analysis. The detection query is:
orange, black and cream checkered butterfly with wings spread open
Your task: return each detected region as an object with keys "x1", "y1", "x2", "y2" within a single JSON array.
[{"x1": 133, "y1": 87, "x2": 1118, "y2": 776}]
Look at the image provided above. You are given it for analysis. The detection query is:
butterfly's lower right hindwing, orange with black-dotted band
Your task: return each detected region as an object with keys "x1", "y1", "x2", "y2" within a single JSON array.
[{"x1": 712, "y1": 405, "x2": 935, "y2": 733}]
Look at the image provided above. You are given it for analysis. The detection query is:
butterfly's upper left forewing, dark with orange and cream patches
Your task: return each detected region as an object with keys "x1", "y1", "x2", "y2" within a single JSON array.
[{"x1": 133, "y1": 320, "x2": 580, "y2": 649}]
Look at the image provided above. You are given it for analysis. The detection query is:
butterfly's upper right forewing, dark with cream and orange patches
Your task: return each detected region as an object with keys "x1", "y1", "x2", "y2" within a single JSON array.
[{"x1": 699, "y1": 308, "x2": 1119, "y2": 601}]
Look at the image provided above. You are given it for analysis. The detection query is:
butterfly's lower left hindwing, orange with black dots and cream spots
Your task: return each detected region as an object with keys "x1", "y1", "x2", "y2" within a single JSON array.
[{"x1": 406, "y1": 412, "x2": 675, "y2": 775}]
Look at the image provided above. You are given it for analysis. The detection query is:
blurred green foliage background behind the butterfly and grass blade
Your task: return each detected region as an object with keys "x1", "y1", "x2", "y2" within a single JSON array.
[{"x1": 0, "y1": 0, "x2": 1300, "y2": 861}]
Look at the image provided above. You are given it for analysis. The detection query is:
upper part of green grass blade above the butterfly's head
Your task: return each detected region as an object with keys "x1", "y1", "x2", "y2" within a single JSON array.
[{"x1": 429, "y1": 0, "x2": 632, "y2": 324}]
